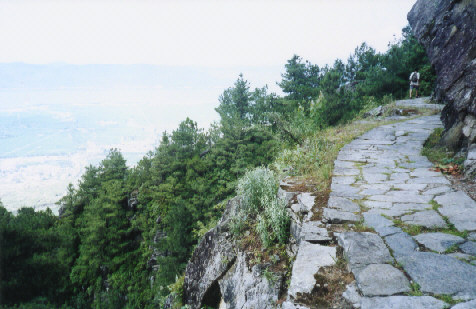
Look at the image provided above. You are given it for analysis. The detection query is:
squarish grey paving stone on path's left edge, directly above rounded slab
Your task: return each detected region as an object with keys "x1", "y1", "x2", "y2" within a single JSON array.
[{"x1": 338, "y1": 232, "x2": 393, "y2": 271}]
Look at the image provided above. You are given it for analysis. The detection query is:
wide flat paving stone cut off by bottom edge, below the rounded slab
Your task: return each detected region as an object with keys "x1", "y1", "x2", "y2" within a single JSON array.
[{"x1": 361, "y1": 296, "x2": 447, "y2": 309}]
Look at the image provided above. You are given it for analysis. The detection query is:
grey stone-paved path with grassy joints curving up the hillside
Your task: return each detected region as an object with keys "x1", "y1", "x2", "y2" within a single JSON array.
[{"x1": 283, "y1": 100, "x2": 476, "y2": 309}]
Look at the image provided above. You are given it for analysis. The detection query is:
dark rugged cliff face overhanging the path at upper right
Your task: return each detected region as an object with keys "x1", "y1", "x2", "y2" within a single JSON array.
[{"x1": 408, "y1": 0, "x2": 476, "y2": 173}]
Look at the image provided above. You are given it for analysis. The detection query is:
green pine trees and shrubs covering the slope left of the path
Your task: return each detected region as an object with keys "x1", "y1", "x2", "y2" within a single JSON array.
[{"x1": 0, "y1": 23, "x2": 438, "y2": 308}]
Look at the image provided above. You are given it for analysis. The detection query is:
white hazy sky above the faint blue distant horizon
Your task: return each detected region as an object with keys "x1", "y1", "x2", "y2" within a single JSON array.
[{"x1": 0, "y1": 0, "x2": 415, "y2": 67}]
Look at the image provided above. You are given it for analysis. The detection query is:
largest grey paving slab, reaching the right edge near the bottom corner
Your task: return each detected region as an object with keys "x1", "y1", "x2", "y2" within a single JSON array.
[{"x1": 397, "y1": 252, "x2": 476, "y2": 299}]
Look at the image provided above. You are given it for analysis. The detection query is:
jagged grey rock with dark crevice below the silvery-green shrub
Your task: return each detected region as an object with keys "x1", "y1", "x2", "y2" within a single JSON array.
[{"x1": 184, "y1": 198, "x2": 284, "y2": 308}]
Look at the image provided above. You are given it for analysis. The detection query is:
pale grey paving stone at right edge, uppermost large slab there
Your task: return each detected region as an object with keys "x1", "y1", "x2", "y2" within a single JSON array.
[{"x1": 435, "y1": 191, "x2": 476, "y2": 231}]
